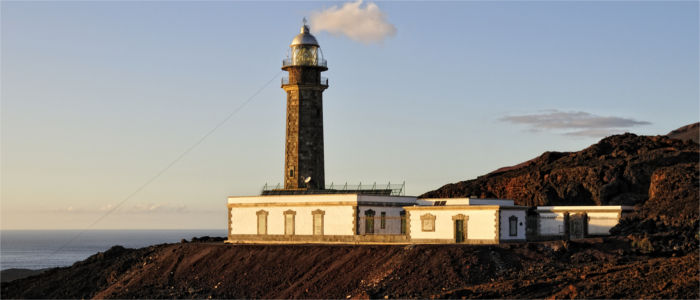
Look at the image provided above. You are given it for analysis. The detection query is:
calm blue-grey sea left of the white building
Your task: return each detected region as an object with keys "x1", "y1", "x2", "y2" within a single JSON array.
[{"x1": 0, "y1": 229, "x2": 226, "y2": 270}]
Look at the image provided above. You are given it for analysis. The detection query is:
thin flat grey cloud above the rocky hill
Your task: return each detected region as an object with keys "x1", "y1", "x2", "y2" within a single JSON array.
[{"x1": 501, "y1": 109, "x2": 651, "y2": 137}]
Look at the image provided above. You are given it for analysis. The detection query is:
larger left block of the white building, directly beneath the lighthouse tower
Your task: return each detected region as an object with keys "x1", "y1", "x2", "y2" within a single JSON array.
[{"x1": 228, "y1": 194, "x2": 416, "y2": 243}]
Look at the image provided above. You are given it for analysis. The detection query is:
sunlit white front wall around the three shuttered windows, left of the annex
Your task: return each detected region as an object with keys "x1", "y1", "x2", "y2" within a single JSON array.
[{"x1": 231, "y1": 205, "x2": 355, "y2": 235}]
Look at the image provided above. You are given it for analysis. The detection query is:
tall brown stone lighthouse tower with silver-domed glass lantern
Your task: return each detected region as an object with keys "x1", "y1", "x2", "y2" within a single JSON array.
[{"x1": 282, "y1": 20, "x2": 328, "y2": 190}]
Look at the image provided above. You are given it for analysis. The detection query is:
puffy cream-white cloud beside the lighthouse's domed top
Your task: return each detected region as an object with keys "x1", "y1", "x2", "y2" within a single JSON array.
[{"x1": 309, "y1": 0, "x2": 396, "y2": 44}]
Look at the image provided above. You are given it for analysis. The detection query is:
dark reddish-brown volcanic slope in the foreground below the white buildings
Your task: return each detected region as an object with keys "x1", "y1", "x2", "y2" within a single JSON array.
[{"x1": 1, "y1": 237, "x2": 700, "y2": 299}]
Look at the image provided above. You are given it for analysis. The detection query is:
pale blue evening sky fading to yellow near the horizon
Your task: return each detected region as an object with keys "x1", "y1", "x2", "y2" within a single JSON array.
[{"x1": 0, "y1": 1, "x2": 700, "y2": 229}]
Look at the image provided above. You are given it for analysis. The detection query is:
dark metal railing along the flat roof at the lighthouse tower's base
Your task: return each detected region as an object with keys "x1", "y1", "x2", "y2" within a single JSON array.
[{"x1": 260, "y1": 182, "x2": 406, "y2": 196}]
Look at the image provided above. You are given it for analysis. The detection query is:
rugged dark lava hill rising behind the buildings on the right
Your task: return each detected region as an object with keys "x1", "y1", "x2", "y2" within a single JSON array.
[{"x1": 421, "y1": 133, "x2": 700, "y2": 208}]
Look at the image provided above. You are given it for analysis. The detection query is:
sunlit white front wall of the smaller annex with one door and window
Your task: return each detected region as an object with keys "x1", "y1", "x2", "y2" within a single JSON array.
[{"x1": 407, "y1": 207, "x2": 498, "y2": 240}]
